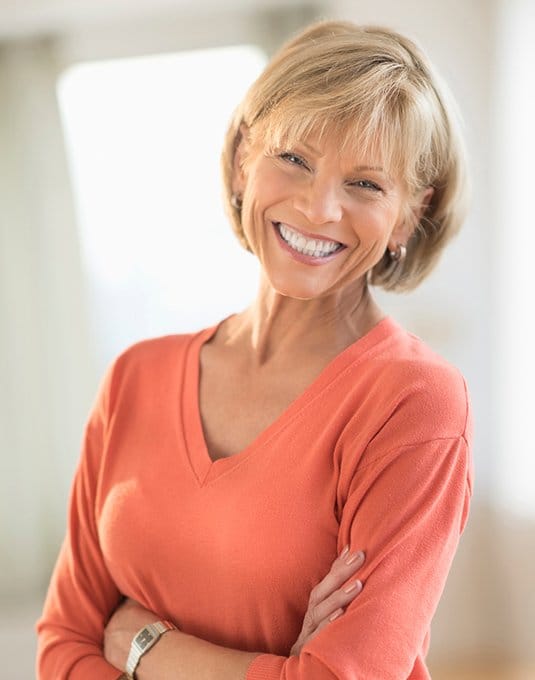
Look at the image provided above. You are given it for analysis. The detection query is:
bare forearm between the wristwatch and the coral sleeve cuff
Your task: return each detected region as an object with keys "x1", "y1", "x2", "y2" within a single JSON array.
[{"x1": 136, "y1": 631, "x2": 259, "y2": 680}]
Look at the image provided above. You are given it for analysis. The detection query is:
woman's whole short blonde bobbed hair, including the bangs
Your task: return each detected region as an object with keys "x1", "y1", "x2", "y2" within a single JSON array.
[{"x1": 222, "y1": 21, "x2": 467, "y2": 291}]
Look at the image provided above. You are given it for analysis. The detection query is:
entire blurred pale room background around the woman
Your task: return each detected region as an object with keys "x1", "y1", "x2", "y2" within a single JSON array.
[{"x1": 0, "y1": 0, "x2": 535, "y2": 680}]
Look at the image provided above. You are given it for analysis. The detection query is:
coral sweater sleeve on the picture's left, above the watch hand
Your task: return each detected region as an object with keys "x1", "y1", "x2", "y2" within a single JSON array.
[{"x1": 37, "y1": 371, "x2": 125, "y2": 680}]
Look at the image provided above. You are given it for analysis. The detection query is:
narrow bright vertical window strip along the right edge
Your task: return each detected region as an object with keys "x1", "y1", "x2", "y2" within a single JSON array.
[{"x1": 493, "y1": 0, "x2": 535, "y2": 517}]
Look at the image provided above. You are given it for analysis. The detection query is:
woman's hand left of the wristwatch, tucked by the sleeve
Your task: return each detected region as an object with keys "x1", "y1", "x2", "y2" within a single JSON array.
[{"x1": 104, "y1": 599, "x2": 160, "y2": 670}]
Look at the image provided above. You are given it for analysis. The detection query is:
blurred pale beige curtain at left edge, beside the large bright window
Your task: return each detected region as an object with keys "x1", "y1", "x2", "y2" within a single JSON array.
[{"x1": 0, "y1": 41, "x2": 94, "y2": 603}]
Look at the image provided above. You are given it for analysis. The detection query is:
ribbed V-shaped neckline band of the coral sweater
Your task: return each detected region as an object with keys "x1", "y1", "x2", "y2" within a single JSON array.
[{"x1": 180, "y1": 315, "x2": 399, "y2": 486}]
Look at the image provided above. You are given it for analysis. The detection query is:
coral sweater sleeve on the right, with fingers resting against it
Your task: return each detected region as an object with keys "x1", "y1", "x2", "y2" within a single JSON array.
[{"x1": 246, "y1": 435, "x2": 471, "y2": 680}]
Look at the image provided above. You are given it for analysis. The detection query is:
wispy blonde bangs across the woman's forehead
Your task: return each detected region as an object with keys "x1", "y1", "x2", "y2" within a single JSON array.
[{"x1": 251, "y1": 70, "x2": 440, "y2": 198}]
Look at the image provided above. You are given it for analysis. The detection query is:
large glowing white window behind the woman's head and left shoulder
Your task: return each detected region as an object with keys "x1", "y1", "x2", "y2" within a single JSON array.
[{"x1": 58, "y1": 46, "x2": 266, "y2": 367}]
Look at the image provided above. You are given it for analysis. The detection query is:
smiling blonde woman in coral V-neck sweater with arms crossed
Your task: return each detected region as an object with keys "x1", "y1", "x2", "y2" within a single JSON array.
[{"x1": 38, "y1": 22, "x2": 471, "y2": 680}]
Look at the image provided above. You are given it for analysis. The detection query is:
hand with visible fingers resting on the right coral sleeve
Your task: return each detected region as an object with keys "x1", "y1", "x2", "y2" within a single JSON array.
[{"x1": 290, "y1": 546, "x2": 366, "y2": 656}]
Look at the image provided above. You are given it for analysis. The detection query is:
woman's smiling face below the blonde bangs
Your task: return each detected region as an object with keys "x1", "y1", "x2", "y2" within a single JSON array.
[{"x1": 233, "y1": 125, "x2": 409, "y2": 300}]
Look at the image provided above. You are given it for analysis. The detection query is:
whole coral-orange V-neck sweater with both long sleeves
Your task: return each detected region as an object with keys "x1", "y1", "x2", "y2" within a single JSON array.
[{"x1": 37, "y1": 318, "x2": 471, "y2": 680}]
